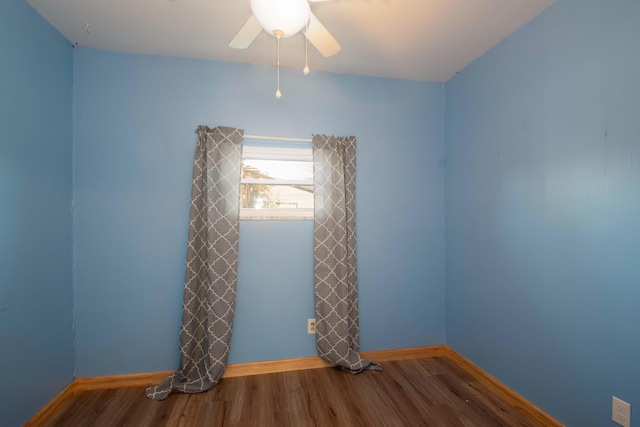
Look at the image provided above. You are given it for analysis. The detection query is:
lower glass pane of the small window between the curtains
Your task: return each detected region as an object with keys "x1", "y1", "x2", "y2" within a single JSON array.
[{"x1": 240, "y1": 184, "x2": 313, "y2": 209}]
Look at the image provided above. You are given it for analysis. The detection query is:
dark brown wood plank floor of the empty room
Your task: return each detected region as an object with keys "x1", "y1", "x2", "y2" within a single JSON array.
[{"x1": 47, "y1": 357, "x2": 536, "y2": 427}]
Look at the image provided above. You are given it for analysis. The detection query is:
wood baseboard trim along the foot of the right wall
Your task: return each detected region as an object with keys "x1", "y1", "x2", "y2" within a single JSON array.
[{"x1": 444, "y1": 346, "x2": 564, "y2": 427}]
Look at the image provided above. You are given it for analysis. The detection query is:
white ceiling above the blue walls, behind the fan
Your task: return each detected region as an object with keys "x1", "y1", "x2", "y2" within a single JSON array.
[{"x1": 28, "y1": 0, "x2": 554, "y2": 82}]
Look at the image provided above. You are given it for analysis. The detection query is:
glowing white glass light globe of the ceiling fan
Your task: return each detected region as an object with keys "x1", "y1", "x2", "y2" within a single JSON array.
[{"x1": 251, "y1": 0, "x2": 311, "y2": 37}]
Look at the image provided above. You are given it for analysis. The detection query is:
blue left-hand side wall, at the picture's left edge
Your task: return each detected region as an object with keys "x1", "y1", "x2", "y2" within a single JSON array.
[{"x1": 0, "y1": 0, "x2": 74, "y2": 426}]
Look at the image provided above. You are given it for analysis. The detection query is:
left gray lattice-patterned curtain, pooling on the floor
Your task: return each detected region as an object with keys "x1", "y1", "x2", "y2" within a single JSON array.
[{"x1": 147, "y1": 126, "x2": 244, "y2": 400}]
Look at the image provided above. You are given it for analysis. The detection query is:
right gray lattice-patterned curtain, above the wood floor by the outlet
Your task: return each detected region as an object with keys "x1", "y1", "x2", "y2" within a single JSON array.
[{"x1": 313, "y1": 135, "x2": 382, "y2": 374}]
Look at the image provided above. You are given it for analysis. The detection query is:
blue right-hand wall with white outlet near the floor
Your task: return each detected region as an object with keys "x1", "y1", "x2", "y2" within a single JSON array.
[{"x1": 445, "y1": 0, "x2": 640, "y2": 426}]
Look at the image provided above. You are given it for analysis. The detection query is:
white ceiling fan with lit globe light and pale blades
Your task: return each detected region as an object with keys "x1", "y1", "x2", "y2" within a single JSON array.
[{"x1": 229, "y1": 0, "x2": 341, "y2": 57}]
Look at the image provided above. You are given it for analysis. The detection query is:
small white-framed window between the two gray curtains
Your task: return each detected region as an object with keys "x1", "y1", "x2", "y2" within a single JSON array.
[{"x1": 240, "y1": 140, "x2": 313, "y2": 219}]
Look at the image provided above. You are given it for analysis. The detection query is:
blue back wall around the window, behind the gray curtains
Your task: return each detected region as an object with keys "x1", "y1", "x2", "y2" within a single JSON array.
[{"x1": 74, "y1": 48, "x2": 445, "y2": 376}]
